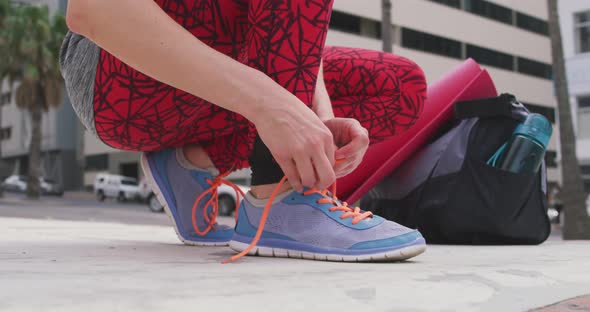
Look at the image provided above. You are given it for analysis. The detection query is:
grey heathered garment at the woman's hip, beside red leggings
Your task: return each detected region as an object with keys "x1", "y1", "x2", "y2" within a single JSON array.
[{"x1": 59, "y1": 31, "x2": 100, "y2": 135}]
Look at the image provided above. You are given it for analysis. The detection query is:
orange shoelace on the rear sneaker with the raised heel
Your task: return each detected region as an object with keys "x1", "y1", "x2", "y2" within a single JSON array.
[{"x1": 191, "y1": 171, "x2": 246, "y2": 236}]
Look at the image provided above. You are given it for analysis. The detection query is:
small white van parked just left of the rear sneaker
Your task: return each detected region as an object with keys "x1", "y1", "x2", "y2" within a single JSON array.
[{"x1": 94, "y1": 173, "x2": 140, "y2": 202}]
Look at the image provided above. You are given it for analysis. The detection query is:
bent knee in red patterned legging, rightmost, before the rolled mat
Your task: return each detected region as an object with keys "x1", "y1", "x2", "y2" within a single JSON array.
[{"x1": 324, "y1": 47, "x2": 426, "y2": 198}]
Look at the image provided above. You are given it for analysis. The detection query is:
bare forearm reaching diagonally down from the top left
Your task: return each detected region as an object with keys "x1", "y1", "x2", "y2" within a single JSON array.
[{"x1": 67, "y1": 0, "x2": 303, "y2": 121}]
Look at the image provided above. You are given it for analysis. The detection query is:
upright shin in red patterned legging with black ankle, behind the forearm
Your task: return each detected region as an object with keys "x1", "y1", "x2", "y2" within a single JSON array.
[{"x1": 248, "y1": 0, "x2": 332, "y2": 190}]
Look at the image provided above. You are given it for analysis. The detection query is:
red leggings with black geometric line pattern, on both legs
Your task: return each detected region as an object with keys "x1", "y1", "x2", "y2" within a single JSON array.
[{"x1": 94, "y1": 0, "x2": 426, "y2": 171}]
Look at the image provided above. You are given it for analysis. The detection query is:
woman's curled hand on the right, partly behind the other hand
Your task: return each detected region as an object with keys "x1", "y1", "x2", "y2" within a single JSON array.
[{"x1": 324, "y1": 118, "x2": 369, "y2": 178}]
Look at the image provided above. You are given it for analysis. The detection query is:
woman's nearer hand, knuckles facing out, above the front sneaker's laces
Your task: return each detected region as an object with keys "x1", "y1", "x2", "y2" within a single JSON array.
[{"x1": 252, "y1": 96, "x2": 336, "y2": 192}]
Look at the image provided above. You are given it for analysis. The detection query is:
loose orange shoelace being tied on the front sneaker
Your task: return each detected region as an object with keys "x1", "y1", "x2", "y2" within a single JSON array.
[{"x1": 221, "y1": 177, "x2": 373, "y2": 263}]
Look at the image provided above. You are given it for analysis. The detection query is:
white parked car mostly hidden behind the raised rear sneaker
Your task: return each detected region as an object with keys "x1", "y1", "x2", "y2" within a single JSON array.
[{"x1": 139, "y1": 179, "x2": 250, "y2": 216}]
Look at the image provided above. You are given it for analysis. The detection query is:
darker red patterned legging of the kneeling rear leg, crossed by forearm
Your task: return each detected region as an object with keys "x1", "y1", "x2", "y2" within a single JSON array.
[{"x1": 94, "y1": 0, "x2": 251, "y2": 171}]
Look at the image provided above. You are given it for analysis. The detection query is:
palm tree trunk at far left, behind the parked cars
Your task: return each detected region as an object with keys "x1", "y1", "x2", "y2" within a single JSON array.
[{"x1": 27, "y1": 93, "x2": 45, "y2": 199}]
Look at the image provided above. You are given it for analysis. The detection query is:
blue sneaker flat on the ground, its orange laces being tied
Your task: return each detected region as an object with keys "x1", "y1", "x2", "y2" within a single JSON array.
[{"x1": 227, "y1": 190, "x2": 426, "y2": 262}]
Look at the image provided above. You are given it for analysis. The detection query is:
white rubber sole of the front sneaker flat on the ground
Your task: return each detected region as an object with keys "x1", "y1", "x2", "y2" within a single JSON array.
[{"x1": 229, "y1": 241, "x2": 426, "y2": 262}]
